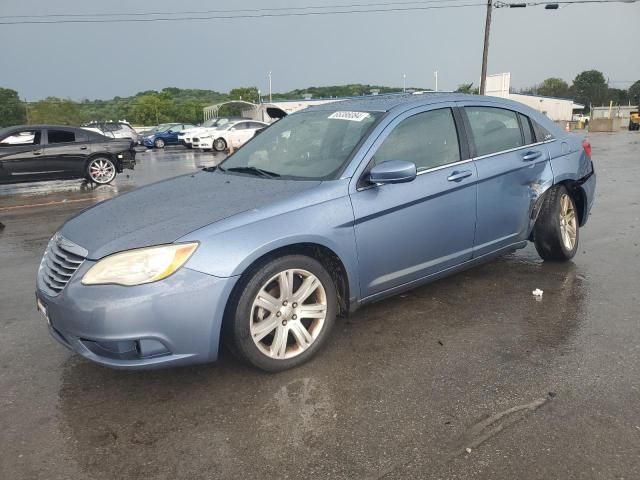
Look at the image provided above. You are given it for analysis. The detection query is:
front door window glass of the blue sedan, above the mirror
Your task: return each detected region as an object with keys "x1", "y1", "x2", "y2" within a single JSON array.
[{"x1": 374, "y1": 108, "x2": 460, "y2": 171}]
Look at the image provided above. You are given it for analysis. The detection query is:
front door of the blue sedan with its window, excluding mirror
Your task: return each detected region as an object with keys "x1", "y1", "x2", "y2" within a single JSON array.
[{"x1": 351, "y1": 108, "x2": 477, "y2": 298}]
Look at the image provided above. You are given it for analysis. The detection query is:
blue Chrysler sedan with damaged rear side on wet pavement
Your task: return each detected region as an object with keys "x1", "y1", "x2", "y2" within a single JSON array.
[{"x1": 36, "y1": 93, "x2": 595, "y2": 371}]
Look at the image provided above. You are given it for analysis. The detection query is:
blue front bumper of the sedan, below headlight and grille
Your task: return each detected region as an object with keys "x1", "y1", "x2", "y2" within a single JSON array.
[{"x1": 36, "y1": 260, "x2": 237, "y2": 369}]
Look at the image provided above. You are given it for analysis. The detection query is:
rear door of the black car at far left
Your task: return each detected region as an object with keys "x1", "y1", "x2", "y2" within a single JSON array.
[{"x1": 44, "y1": 127, "x2": 91, "y2": 177}]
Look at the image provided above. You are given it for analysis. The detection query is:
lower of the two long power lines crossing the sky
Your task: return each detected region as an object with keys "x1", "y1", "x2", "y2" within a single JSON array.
[{"x1": 0, "y1": 3, "x2": 485, "y2": 25}]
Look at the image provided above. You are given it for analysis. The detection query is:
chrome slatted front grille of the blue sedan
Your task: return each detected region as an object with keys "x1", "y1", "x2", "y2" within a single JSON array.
[{"x1": 38, "y1": 234, "x2": 88, "y2": 296}]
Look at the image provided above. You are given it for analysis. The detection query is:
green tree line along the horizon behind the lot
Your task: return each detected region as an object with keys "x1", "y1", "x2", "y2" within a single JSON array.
[{"x1": 0, "y1": 70, "x2": 640, "y2": 127}]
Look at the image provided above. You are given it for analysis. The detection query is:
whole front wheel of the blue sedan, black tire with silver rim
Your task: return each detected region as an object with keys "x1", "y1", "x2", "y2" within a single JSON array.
[{"x1": 227, "y1": 255, "x2": 337, "y2": 372}]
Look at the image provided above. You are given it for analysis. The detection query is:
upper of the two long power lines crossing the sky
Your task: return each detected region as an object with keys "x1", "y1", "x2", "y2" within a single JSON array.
[{"x1": 0, "y1": 0, "x2": 476, "y2": 19}]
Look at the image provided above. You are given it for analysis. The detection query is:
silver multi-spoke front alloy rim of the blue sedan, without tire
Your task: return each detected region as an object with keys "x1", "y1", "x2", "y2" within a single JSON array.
[{"x1": 249, "y1": 269, "x2": 327, "y2": 360}]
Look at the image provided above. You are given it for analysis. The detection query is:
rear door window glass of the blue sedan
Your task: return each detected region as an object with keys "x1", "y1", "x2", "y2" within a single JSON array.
[{"x1": 465, "y1": 107, "x2": 523, "y2": 156}]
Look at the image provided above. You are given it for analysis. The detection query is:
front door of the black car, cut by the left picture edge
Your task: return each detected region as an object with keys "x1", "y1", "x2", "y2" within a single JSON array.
[{"x1": 0, "y1": 128, "x2": 45, "y2": 182}]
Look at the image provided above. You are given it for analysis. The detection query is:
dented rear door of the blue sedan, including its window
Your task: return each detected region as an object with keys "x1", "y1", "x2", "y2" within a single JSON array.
[{"x1": 462, "y1": 103, "x2": 553, "y2": 257}]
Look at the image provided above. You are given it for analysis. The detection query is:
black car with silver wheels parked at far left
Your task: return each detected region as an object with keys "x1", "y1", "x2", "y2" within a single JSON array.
[{"x1": 0, "y1": 125, "x2": 135, "y2": 184}]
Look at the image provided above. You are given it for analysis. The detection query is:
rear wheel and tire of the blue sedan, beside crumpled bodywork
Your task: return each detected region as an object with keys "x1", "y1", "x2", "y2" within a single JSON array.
[{"x1": 533, "y1": 185, "x2": 580, "y2": 262}]
